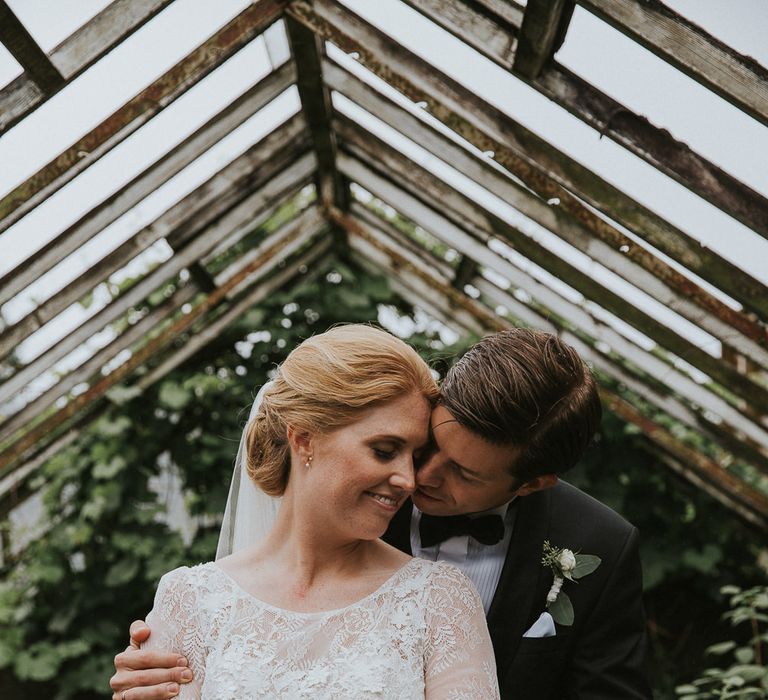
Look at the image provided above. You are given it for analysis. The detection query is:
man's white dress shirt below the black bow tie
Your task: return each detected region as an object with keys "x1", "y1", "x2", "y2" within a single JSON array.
[{"x1": 411, "y1": 502, "x2": 517, "y2": 615}]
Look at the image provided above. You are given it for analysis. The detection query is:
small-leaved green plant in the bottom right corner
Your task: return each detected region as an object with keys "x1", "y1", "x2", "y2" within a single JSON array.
[{"x1": 676, "y1": 586, "x2": 768, "y2": 700}]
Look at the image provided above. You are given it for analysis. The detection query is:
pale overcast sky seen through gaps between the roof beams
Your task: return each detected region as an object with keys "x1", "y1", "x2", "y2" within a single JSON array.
[{"x1": 0, "y1": 0, "x2": 768, "y2": 390}]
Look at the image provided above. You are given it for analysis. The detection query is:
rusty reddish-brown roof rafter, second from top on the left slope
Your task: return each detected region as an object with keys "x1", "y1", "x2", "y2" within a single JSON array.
[{"x1": 0, "y1": 0, "x2": 280, "y2": 233}]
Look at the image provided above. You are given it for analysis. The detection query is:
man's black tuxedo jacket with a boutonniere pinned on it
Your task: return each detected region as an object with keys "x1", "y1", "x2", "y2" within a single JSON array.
[{"x1": 384, "y1": 481, "x2": 652, "y2": 700}]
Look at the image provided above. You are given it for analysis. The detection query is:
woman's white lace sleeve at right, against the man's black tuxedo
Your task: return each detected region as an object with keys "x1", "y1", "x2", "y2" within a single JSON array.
[{"x1": 425, "y1": 562, "x2": 499, "y2": 700}]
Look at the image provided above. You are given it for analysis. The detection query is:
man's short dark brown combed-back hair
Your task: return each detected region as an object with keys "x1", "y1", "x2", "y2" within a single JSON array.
[{"x1": 440, "y1": 328, "x2": 602, "y2": 484}]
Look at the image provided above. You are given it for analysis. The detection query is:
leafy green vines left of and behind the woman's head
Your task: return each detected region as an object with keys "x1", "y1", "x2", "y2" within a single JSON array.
[{"x1": 0, "y1": 262, "x2": 450, "y2": 700}]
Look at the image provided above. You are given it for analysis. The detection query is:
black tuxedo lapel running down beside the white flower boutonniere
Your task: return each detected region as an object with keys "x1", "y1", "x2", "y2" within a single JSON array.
[{"x1": 488, "y1": 489, "x2": 551, "y2": 669}]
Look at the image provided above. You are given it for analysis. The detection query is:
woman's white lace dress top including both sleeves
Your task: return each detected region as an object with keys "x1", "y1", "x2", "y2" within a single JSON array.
[{"x1": 143, "y1": 559, "x2": 499, "y2": 700}]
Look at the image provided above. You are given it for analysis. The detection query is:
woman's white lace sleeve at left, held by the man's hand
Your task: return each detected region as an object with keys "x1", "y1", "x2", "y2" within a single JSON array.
[{"x1": 141, "y1": 566, "x2": 205, "y2": 700}]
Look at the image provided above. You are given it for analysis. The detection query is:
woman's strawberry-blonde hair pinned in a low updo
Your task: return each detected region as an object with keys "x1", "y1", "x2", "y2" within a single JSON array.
[{"x1": 246, "y1": 324, "x2": 438, "y2": 496}]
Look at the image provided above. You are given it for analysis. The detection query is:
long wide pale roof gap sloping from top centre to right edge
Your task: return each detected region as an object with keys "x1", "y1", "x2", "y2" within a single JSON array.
[{"x1": 342, "y1": 0, "x2": 768, "y2": 282}]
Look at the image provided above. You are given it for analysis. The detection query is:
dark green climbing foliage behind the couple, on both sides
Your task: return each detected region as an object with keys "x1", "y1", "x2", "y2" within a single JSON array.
[{"x1": 0, "y1": 258, "x2": 765, "y2": 700}]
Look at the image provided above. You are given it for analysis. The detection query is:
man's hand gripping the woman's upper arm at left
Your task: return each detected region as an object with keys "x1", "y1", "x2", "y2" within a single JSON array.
[{"x1": 109, "y1": 620, "x2": 192, "y2": 700}]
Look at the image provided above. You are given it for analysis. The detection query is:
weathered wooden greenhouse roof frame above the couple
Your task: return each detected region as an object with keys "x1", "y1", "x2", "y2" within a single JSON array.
[{"x1": 0, "y1": 0, "x2": 768, "y2": 530}]
